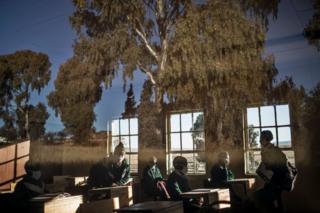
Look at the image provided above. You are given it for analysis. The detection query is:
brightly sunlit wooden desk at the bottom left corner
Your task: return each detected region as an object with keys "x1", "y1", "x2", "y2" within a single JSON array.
[{"x1": 30, "y1": 194, "x2": 83, "y2": 213}]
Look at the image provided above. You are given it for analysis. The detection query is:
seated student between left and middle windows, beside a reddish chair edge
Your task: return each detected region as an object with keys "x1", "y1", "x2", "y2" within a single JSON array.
[{"x1": 142, "y1": 156, "x2": 169, "y2": 200}]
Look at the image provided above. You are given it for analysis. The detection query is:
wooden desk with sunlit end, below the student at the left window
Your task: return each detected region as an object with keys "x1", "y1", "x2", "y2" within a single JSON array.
[{"x1": 88, "y1": 186, "x2": 133, "y2": 208}]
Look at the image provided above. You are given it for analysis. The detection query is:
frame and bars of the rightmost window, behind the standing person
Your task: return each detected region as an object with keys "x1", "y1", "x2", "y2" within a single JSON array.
[{"x1": 243, "y1": 103, "x2": 295, "y2": 175}]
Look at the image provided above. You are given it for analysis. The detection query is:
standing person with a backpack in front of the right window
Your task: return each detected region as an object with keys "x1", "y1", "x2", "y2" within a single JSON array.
[{"x1": 254, "y1": 130, "x2": 296, "y2": 212}]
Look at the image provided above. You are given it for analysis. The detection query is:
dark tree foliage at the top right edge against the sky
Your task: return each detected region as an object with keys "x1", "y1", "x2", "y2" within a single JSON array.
[{"x1": 304, "y1": 0, "x2": 320, "y2": 50}]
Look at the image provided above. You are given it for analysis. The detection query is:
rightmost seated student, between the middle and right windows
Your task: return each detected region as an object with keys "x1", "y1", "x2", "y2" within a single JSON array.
[{"x1": 211, "y1": 152, "x2": 234, "y2": 188}]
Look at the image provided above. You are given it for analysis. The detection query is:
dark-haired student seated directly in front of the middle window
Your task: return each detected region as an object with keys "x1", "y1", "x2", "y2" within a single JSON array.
[{"x1": 167, "y1": 156, "x2": 201, "y2": 212}]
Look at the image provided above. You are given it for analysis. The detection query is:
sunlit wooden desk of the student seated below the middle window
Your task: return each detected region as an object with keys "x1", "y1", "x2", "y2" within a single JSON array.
[{"x1": 180, "y1": 189, "x2": 230, "y2": 209}]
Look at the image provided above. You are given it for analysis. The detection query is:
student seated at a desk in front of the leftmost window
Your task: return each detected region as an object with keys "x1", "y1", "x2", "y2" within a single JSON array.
[{"x1": 88, "y1": 142, "x2": 130, "y2": 188}]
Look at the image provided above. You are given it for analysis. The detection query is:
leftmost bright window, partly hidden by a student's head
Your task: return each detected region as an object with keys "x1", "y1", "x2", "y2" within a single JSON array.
[{"x1": 111, "y1": 118, "x2": 138, "y2": 173}]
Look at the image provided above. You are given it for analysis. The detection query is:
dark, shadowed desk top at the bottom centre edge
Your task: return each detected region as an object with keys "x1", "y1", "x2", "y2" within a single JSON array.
[{"x1": 115, "y1": 201, "x2": 183, "y2": 213}]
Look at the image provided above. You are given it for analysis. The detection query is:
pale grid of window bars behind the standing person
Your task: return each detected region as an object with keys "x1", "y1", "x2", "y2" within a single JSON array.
[{"x1": 244, "y1": 105, "x2": 294, "y2": 174}]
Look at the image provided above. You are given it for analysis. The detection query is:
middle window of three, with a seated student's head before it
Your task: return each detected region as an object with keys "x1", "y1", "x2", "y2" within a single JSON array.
[{"x1": 166, "y1": 112, "x2": 206, "y2": 174}]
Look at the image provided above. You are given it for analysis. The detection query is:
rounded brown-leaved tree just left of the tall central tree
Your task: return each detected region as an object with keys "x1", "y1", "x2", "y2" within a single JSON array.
[{"x1": 48, "y1": 55, "x2": 102, "y2": 143}]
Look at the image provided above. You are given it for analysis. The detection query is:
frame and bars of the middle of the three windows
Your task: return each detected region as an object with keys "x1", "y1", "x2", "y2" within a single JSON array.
[{"x1": 166, "y1": 109, "x2": 207, "y2": 175}]
